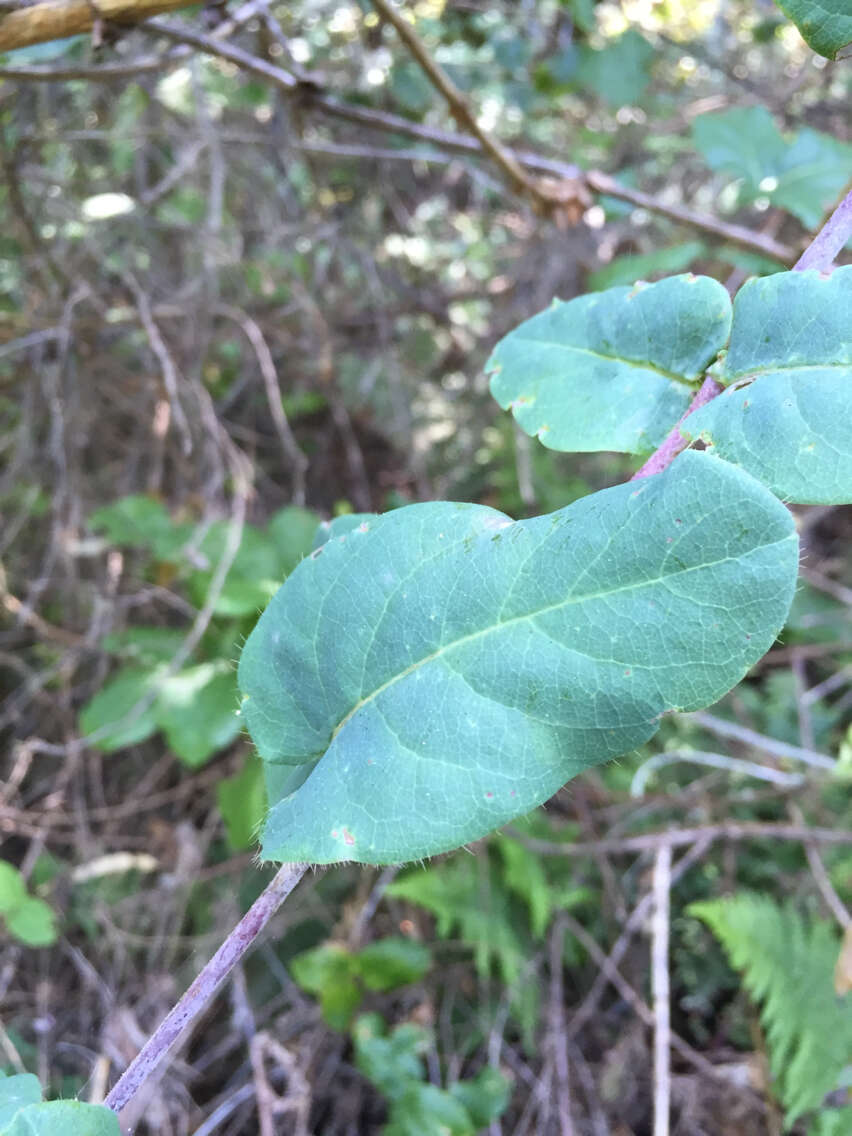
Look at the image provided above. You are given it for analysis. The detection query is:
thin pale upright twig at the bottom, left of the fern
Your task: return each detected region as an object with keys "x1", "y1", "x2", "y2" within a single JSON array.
[{"x1": 651, "y1": 844, "x2": 671, "y2": 1136}]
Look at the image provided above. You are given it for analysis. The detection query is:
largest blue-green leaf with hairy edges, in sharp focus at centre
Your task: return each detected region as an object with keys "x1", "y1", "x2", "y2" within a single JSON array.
[{"x1": 239, "y1": 452, "x2": 797, "y2": 863}]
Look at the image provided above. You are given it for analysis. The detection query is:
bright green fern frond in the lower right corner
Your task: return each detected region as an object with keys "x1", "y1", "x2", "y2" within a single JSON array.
[{"x1": 688, "y1": 893, "x2": 852, "y2": 1125}]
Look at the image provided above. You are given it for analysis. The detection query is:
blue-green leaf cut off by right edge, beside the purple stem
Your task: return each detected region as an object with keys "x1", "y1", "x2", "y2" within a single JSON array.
[{"x1": 683, "y1": 267, "x2": 852, "y2": 504}]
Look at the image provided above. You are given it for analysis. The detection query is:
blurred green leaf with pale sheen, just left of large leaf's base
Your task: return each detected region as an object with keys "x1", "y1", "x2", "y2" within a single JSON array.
[{"x1": 153, "y1": 660, "x2": 242, "y2": 768}]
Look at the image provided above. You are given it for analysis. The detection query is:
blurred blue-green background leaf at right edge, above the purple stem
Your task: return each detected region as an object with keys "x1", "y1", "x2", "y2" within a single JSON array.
[{"x1": 692, "y1": 107, "x2": 852, "y2": 228}]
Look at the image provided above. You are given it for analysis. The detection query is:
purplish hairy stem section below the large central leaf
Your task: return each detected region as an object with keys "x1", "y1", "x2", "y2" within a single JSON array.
[{"x1": 105, "y1": 863, "x2": 308, "y2": 1112}]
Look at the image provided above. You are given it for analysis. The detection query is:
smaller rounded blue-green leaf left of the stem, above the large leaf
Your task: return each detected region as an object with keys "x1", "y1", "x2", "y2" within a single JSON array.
[{"x1": 486, "y1": 275, "x2": 730, "y2": 453}]
